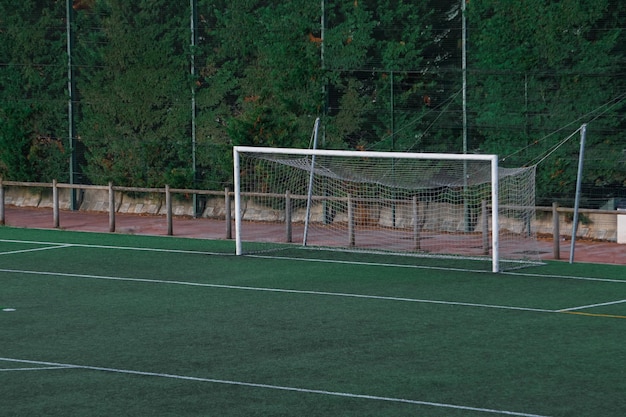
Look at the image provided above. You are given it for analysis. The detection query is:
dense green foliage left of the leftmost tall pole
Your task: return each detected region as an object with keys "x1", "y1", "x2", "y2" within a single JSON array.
[{"x1": 0, "y1": 0, "x2": 68, "y2": 181}]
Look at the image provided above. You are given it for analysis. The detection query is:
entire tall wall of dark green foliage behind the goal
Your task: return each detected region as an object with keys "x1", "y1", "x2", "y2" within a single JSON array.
[{"x1": 0, "y1": 0, "x2": 626, "y2": 202}]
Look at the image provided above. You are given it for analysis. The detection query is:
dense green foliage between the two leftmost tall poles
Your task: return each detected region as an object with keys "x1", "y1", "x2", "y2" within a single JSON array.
[{"x1": 77, "y1": 0, "x2": 193, "y2": 187}]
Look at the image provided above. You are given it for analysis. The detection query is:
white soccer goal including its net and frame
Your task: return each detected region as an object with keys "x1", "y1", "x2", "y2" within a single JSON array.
[{"x1": 234, "y1": 146, "x2": 537, "y2": 272}]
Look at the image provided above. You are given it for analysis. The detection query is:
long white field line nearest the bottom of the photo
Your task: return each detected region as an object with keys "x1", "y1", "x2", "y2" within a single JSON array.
[{"x1": 0, "y1": 357, "x2": 547, "y2": 417}]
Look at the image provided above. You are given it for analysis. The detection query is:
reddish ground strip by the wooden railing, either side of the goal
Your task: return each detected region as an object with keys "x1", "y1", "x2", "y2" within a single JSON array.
[{"x1": 0, "y1": 206, "x2": 626, "y2": 265}]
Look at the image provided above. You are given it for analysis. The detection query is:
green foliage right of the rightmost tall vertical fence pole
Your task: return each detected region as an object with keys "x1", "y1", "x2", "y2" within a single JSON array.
[{"x1": 469, "y1": 0, "x2": 626, "y2": 203}]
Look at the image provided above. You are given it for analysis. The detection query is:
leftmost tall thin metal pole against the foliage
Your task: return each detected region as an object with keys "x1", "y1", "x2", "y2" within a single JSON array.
[{"x1": 65, "y1": 0, "x2": 78, "y2": 210}]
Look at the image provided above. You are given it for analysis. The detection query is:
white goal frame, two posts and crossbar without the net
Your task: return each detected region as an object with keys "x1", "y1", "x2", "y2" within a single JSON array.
[{"x1": 233, "y1": 146, "x2": 500, "y2": 272}]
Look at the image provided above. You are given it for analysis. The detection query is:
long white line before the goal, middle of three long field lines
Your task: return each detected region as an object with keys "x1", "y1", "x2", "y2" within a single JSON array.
[{"x1": 0, "y1": 269, "x2": 557, "y2": 313}]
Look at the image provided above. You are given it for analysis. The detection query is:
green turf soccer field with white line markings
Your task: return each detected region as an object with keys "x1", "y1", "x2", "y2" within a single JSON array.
[{"x1": 0, "y1": 227, "x2": 626, "y2": 417}]
